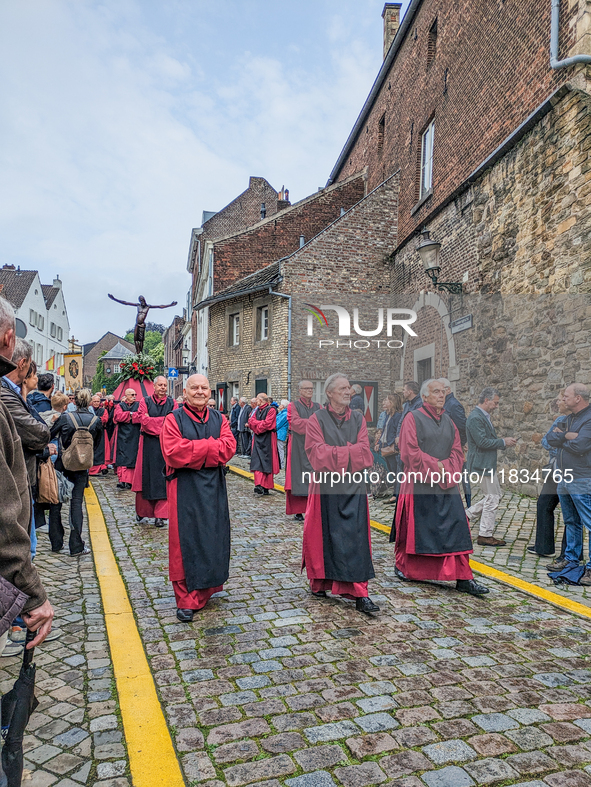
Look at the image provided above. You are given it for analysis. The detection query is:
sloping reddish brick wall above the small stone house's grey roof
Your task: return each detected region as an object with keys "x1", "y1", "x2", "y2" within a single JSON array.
[{"x1": 213, "y1": 175, "x2": 365, "y2": 292}]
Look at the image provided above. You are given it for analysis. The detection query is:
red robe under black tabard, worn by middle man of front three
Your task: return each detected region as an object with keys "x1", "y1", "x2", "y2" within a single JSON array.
[{"x1": 302, "y1": 408, "x2": 373, "y2": 598}]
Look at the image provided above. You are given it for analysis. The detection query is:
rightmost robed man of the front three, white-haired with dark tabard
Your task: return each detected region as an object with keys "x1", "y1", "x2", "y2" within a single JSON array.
[{"x1": 396, "y1": 380, "x2": 489, "y2": 596}]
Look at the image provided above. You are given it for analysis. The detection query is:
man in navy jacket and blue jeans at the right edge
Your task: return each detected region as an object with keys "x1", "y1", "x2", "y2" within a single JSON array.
[{"x1": 546, "y1": 383, "x2": 591, "y2": 586}]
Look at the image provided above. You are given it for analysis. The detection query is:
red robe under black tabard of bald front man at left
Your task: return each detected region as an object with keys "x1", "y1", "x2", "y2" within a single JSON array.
[{"x1": 160, "y1": 407, "x2": 236, "y2": 610}]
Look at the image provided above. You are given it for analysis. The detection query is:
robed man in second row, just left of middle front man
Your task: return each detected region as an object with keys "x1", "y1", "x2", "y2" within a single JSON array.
[{"x1": 285, "y1": 380, "x2": 320, "y2": 521}]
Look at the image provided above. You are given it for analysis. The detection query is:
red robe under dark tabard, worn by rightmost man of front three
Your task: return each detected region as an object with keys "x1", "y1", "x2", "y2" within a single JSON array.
[{"x1": 396, "y1": 404, "x2": 473, "y2": 582}]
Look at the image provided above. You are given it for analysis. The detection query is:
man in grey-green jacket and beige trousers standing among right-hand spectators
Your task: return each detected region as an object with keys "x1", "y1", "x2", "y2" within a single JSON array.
[{"x1": 466, "y1": 388, "x2": 517, "y2": 547}]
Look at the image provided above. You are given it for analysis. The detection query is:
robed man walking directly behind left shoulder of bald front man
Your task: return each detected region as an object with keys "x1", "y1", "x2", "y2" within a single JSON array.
[{"x1": 131, "y1": 376, "x2": 177, "y2": 527}]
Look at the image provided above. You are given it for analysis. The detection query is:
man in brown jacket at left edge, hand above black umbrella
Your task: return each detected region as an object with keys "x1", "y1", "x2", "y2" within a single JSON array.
[{"x1": 0, "y1": 298, "x2": 53, "y2": 651}]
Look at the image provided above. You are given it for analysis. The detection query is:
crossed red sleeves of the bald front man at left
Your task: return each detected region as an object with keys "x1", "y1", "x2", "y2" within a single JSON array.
[{"x1": 160, "y1": 415, "x2": 236, "y2": 470}]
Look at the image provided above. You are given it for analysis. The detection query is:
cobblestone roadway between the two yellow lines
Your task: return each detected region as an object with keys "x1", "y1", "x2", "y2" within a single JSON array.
[{"x1": 88, "y1": 474, "x2": 591, "y2": 787}]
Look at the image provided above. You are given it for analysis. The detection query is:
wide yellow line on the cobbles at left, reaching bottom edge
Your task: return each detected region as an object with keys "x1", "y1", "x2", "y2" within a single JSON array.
[{"x1": 86, "y1": 486, "x2": 185, "y2": 787}]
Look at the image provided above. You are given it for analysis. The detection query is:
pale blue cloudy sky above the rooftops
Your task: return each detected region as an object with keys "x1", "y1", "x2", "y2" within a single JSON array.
[{"x1": 0, "y1": 0, "x2": 408, "y2": 342}]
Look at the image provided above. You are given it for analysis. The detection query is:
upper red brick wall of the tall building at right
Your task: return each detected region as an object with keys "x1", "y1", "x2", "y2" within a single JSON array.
[{"x1": 338, "y1": 0, "x2": 589, "y2": 242}]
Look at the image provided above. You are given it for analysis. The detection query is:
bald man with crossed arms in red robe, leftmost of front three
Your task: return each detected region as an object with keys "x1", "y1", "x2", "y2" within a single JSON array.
[{"x1": 160, "y1": 374, "x2": 236, "y2": 623}]
